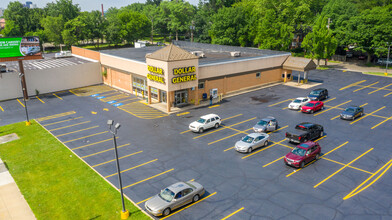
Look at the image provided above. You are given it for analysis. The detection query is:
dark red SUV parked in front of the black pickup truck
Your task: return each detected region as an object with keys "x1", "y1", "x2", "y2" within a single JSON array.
[{"x1": 284, "y1": 141, "x2": 321, "y2": 168}]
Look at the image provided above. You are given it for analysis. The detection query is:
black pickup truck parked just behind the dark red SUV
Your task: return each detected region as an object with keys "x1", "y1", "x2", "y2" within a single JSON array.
[{"x1": 286, "y1": 122, "x2": 324, "y2": 143}]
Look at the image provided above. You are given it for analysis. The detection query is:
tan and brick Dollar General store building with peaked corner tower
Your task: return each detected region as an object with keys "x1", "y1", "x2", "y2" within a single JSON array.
[{"x1": 72, "y1": 41, "x2": 315, "y2": 112}]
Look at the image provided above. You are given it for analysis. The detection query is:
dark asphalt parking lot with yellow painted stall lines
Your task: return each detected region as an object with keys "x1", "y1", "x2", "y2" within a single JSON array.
[{"x1": 0, "y1": 70, "x2": 392, "y2": 219}]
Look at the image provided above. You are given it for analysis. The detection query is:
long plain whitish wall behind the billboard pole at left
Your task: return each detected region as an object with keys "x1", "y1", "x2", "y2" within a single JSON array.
[{"x1": 0, "y1": 62, "x2": 102, "y2": 101}]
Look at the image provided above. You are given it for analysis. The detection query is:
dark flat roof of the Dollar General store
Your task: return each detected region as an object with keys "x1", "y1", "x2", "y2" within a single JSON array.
[{"x1": 100, "y1": 41, "x2": 290, "y2": 65}]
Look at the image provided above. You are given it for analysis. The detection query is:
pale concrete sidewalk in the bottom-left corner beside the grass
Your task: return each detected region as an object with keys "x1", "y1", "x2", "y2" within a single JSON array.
[{"x1": 0, "y1": 159, "x2": 36, "y2": 220}]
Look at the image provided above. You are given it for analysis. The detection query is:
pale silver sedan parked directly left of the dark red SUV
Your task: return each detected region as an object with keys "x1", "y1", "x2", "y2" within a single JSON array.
[{"x1": 234, "y1": 133, "x2": 269, "y2": 153}]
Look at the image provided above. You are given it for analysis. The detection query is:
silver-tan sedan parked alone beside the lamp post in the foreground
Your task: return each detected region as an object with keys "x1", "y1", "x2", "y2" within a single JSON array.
[{"x1": 144, "y1": 181, "x2": 205, "y2": 216}]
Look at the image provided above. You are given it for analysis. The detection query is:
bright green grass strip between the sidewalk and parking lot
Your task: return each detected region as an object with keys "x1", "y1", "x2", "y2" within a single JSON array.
[{"x1": 0, "y1": 121, "x2": 150, "y2": 220}]
